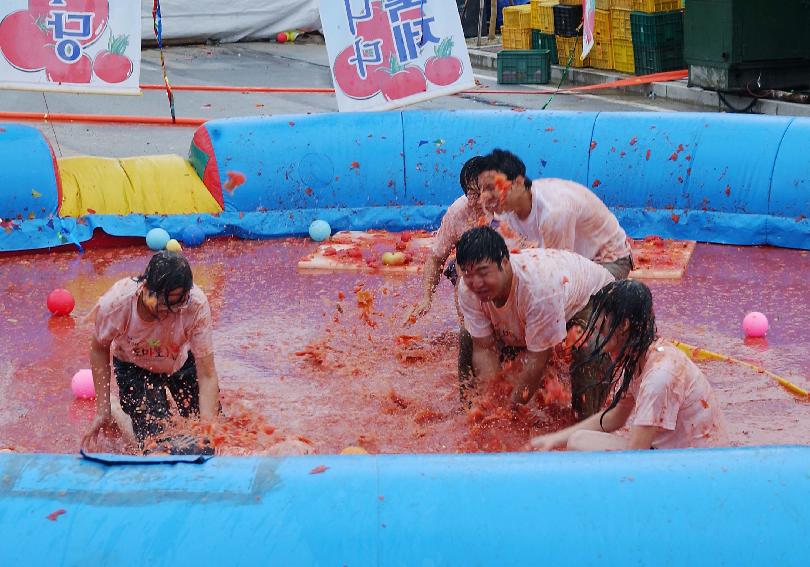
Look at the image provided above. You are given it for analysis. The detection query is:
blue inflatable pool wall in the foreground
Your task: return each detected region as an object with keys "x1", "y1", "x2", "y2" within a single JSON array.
[{"x1": 0, "y1": 447, "x2": 810, "y2": 567}]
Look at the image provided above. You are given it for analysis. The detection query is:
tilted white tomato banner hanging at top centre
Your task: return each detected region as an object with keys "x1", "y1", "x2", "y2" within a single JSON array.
[{"x1": 321, "y1": 0, "x2": 475, "y2": 111}]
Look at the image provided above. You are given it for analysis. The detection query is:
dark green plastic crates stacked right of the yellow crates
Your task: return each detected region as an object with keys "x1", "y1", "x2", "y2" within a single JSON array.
[{"x1": 630, "y1": 6, "x2": 684, "y2": 75}]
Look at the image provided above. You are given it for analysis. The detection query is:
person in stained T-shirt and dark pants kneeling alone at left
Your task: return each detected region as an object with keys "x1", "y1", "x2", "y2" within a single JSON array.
[{"x1": 82, "y1": 251, "x2": 220, "y2": 453}]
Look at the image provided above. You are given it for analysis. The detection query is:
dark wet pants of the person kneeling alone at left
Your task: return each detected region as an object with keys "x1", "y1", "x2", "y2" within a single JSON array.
[{"x1": 113, "y1": 352, "x2": 200, "y2": 443}]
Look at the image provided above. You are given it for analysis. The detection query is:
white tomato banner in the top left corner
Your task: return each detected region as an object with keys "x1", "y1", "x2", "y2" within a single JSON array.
[{"x1": 0, "y1": 0, "x2": 141, "y2": 94}]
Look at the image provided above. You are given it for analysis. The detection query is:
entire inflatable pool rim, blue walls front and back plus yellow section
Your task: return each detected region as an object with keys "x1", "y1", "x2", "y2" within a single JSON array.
[{"x1": 0, "y1": 111, "x2": 810, "y2": 565}]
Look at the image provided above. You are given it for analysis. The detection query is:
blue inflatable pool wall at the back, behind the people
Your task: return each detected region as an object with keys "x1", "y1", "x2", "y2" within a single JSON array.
[{"x1": 0, "y1": 111, "x2": 810, "y2": 251}]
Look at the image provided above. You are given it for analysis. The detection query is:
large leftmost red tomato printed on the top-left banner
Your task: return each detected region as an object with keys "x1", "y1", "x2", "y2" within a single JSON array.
[{"x1": 0, "y1": 10, "x2": 53, "y2": 71}]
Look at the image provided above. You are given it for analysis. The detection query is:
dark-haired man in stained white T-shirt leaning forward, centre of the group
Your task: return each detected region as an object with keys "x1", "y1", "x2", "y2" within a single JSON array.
[{"x1": 456, "y1": 227, "x2": 613, "y2": 419}]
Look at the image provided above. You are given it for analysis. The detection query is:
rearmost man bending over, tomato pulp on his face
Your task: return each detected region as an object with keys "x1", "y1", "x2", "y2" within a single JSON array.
[{"x1": 477, "y1": 149, "x2": 633, "y2": 279}]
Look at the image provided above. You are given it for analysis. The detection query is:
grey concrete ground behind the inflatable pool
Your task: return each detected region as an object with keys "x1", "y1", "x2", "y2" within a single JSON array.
[{"x1": 0, "y1": 42, "x2": 711, "y2": 157}]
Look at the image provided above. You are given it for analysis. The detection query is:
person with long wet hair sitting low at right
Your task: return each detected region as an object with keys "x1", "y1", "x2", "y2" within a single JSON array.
[{"x1": 531, "y1": 280, "x2": 725, "y2": 451}]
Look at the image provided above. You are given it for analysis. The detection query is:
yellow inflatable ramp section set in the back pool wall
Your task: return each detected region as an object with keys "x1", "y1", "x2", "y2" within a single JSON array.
[{"x1": 58, "y1": 155, "x2": 222, "y2": 217}]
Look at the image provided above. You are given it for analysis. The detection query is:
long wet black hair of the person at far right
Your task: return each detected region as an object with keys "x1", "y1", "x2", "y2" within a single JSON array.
[{"x1": 571, "y1": 280, "x2": 658, "y2": 426}]
